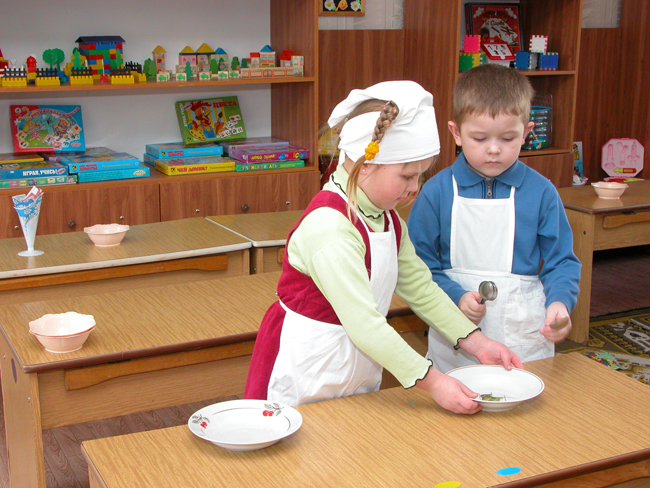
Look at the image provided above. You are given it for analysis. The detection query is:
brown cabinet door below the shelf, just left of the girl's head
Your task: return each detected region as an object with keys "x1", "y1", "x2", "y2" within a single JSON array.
[{"x1": 160, "y1": 171, "x2": 319, "y2": 221}]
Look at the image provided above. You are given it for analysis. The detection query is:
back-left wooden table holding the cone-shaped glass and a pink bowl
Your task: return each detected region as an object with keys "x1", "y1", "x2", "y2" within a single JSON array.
[{"x1": 0, "y1": 218, "x2": 251, "y2": 290}]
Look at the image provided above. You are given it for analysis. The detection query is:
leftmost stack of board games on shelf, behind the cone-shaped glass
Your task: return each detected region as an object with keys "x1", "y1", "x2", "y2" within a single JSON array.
[{"x1": 0, "y1": 154, "x2": 77, "y2": 188}]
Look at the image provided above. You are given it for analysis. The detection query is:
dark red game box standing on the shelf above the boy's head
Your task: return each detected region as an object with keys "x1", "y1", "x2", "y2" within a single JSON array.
[{"x1": 465, "y1": 2, "x2": 522, "y2": 51}]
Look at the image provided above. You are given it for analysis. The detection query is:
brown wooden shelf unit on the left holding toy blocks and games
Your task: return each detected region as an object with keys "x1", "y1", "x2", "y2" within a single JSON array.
[{"x1": 0, "y1": 0, "x2": 320, "y2": 238}]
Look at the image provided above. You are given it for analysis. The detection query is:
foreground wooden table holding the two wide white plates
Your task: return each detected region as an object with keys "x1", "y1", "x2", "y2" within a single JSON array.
[{"x1": 82, "y1": 353, "x2": 650, "y2": 488}]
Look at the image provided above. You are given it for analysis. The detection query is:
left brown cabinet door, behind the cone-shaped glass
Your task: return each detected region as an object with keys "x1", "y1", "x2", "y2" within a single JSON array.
[{"x1": 0, "y1": 183, "x2": 160, "y2": 238}]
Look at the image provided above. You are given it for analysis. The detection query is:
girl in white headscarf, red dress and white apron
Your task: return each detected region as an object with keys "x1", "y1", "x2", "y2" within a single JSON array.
[{"x1": 244, "y1": 81, "x2": 521, "y2": 413}]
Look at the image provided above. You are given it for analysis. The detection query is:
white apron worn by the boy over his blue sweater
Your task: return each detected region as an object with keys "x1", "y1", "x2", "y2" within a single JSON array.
[{"x1": 427, "y1": 177, "x2": 555, "y2": 373}]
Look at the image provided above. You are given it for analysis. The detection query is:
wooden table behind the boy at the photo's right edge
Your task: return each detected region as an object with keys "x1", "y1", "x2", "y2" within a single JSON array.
[{"x1": 558, "y1": 180, "x2": 650, "y2": 343}]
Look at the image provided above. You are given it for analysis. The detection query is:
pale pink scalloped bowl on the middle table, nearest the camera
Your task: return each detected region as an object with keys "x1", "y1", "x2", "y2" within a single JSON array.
[{"x1": 29, "y1": 312, "x2": 95, "y2": 353}]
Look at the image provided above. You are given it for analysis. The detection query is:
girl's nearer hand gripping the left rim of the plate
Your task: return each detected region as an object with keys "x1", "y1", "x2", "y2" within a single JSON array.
[{"x1": 416, "y1": 367, "x2": 482, "y2": 415}]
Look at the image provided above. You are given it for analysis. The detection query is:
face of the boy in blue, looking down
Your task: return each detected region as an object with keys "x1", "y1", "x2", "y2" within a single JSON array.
[{"x1": 449, "y1": 114, "x2": 535, "y2": 178}]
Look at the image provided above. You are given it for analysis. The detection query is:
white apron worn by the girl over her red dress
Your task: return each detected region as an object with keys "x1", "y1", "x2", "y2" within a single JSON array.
[{"x1": 267, "y1": 183, "x2": 397, "y2": 405}]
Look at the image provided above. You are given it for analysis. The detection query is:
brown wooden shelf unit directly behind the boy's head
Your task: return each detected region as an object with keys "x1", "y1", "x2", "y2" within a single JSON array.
[{"x1": 404, "y1": 0, "x2": 582, "y2": 187}]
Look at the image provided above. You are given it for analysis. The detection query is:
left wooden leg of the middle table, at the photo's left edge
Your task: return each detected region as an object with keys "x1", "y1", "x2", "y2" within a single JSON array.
[{"x1": 0, "y1": 336, "x2": 45, "y2": 488}]
